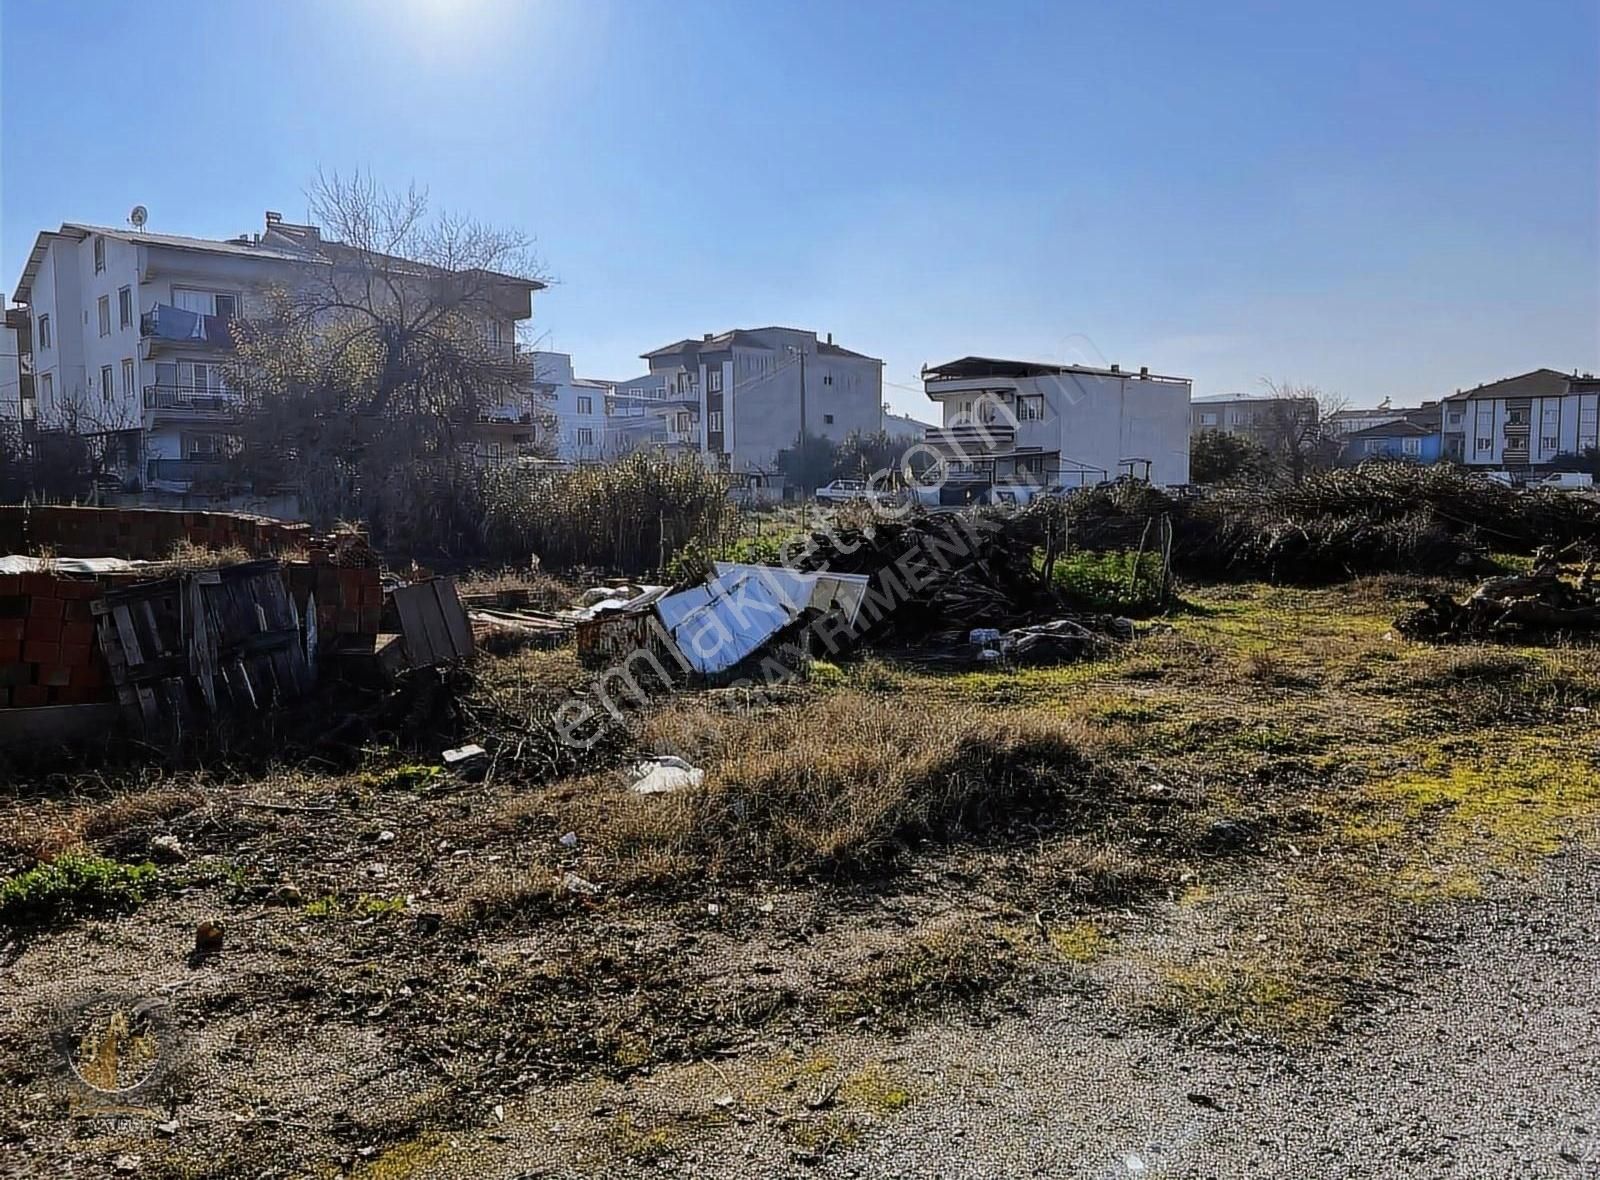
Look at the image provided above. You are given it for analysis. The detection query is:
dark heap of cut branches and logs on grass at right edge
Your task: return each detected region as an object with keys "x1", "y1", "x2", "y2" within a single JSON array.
[{"x1": 1395, "y1": 548, "x2": 1600, "y2": 643}]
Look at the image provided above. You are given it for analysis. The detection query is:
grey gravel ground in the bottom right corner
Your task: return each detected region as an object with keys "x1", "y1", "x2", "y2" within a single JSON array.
[{"x1": 806, "y1": 854, "x2": 1600, "y2": 1180}]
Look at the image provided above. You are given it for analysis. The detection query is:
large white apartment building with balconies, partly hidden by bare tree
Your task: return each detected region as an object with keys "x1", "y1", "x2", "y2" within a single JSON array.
[{"x1": 16, "y1": 213, "x2": 544, "y2": 492}]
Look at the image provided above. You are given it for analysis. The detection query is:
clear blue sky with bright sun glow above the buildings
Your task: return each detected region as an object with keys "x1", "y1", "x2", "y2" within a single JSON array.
[{"x1": 0, "y1": 0, "x2": 1600, "y2": 416}]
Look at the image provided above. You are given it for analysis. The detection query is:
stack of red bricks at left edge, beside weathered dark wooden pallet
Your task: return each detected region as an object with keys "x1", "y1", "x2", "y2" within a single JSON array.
[{"x1": 0, "y1": 572, "x2": 114, "y2": 708}]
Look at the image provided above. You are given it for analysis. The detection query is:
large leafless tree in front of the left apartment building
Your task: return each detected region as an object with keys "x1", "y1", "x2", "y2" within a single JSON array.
[{"x1": 232, "y1": 173, "x2": 542, "y2": 550}]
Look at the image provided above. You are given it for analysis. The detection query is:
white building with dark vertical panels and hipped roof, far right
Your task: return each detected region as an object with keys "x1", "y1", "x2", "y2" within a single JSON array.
[{"x1": 1442, "y1": 369, "x2": 1600, "y2": 472}]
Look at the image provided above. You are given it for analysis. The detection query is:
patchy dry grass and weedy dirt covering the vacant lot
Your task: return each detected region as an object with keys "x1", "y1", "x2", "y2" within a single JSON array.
[{"x1": 0, "y1": 579, "x2": 1600, "y2": 1178}]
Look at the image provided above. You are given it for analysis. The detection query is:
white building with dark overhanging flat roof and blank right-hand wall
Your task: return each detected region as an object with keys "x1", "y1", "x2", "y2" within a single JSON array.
[{"x1": 922, "y1": 357, "x2": 1190, "y2": 486}]
